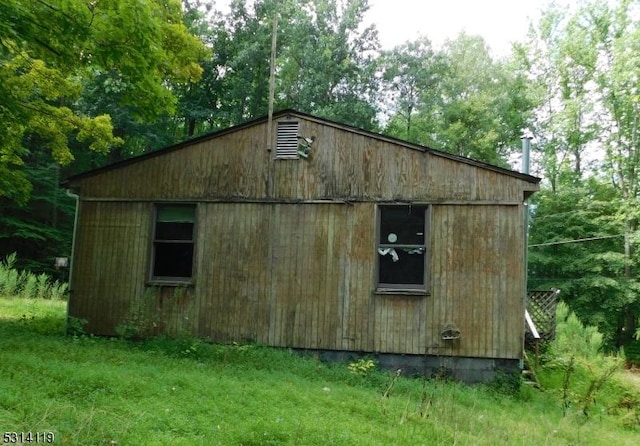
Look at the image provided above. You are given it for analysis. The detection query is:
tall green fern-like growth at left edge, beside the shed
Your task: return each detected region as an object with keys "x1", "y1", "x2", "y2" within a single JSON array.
[{"x1": 0, "y1": 253, "x2": 68, "y2": 299}]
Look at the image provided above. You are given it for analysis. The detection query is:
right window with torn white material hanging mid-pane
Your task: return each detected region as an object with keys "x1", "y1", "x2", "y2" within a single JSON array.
[{"x1": 378, "y1": 205, "x2": 429, "y2": 291}]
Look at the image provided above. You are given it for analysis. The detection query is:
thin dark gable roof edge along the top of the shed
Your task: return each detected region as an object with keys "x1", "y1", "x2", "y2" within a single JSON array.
[{"x1": 62, "y1": 109, "x2": 540, "y2": 186}]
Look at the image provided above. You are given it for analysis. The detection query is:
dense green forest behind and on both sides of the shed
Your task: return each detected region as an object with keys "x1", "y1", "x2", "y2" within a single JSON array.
[{"x1": 0, "y1": 0, "x2": 640, "y2": 349}]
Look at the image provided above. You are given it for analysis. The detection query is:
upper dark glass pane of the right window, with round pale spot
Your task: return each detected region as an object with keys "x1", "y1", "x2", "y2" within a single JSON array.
[{"x1": 380, "y1": 206, "x2": 425, "y2": 245}]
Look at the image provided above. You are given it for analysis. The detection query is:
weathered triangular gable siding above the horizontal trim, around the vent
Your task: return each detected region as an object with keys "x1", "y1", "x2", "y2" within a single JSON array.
[{"x1": 71, "y1": 116, "x2": 536, "y2": 202}]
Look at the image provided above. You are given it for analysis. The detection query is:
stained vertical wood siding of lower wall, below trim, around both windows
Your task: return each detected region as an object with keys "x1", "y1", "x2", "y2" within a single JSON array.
[{"x1": 70, "y1": 202, "x2": 524, "y2": 358}]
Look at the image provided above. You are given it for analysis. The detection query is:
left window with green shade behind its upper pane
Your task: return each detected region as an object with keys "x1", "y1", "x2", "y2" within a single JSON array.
[{"x1": 151, "y1": 205, "x2": 196, "y2": 281}]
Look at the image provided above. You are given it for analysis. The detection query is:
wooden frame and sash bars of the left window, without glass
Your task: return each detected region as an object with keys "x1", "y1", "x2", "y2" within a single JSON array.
[{"x1": 148, "y1": 202, "x2": 198, "y2": 286}]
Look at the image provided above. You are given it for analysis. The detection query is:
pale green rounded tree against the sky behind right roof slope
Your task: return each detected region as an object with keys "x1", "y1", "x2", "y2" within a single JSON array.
[{"x1": 436, "y1": 33, "x2": 531, "y2": 165}]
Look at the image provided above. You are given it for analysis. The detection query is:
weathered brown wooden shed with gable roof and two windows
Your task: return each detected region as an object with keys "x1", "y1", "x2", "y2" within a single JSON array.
[{"x1": 66, "y1": 110, "x2": 539, "y2": 381}]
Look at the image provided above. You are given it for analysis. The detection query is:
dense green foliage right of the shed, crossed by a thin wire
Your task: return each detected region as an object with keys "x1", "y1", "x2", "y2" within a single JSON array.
[{"x1": 529, "y1": 180, "x2": 640, "y2": 350}]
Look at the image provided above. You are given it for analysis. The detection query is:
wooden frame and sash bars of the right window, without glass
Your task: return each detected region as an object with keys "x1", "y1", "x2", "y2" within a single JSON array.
[{"x1": 375, "y1": 203, "x2": 431, "y2": 295}]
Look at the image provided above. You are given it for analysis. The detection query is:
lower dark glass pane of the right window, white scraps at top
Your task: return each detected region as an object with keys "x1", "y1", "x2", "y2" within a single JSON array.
[{"x1": 378, "y1": 248, "x2": 425, "y2": 285}]
